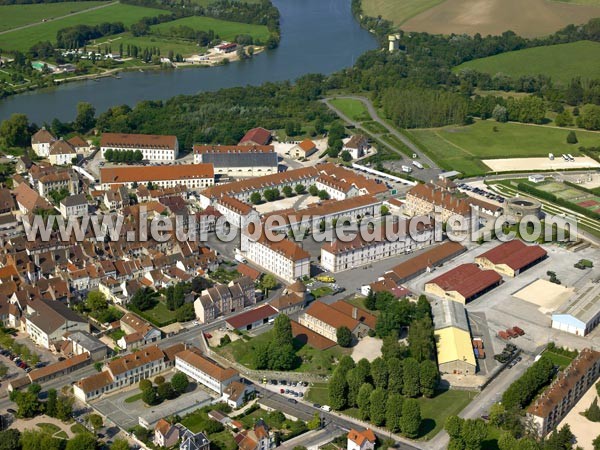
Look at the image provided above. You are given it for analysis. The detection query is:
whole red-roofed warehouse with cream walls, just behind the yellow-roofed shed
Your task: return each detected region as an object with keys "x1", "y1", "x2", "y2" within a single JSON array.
[{"x1": 425, "y1": 263, "x2": 502, "y2": 305}]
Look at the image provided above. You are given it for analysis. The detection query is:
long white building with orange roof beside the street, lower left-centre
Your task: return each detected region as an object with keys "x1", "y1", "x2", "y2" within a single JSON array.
[{"x1": 175, "y1": 350, "x2": 240, "y2": 395}]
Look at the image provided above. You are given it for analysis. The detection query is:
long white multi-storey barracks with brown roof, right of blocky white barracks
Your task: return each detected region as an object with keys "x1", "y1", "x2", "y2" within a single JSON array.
[{"x1": 321, "y1": 218, "x2": 434, "y2": 273}]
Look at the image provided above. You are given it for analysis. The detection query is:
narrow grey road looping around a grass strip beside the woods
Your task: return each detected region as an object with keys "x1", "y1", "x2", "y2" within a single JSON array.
[{"x1": 322, "y1": 95, "x2": 441, "y2": 181}]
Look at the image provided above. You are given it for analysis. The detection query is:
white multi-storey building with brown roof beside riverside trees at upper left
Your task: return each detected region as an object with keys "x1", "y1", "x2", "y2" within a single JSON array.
[{"x1": 100, "y1": 133, "x2": 179, "y2": 161}]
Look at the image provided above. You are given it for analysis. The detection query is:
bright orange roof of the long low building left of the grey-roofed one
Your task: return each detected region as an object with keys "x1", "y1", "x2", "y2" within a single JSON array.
[{"x1": 100, "y1": 164, "x2": 215, "y2": 184}]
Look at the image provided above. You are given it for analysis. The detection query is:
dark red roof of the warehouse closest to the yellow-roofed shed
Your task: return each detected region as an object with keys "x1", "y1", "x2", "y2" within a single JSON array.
[{"x1": 427, "y1": 263, "x2": 502, "y2": 299}]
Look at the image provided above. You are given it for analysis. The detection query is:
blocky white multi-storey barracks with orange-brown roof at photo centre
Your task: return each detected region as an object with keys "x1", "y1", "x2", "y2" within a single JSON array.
[{"x1": 242, "y1": 233, "x2": 310, "y2": 283}]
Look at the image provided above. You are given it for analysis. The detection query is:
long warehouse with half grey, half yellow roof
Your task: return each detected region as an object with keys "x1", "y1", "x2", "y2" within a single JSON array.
[{"x1": 431, "y1": 299, "x2": 477, "y2": 374}]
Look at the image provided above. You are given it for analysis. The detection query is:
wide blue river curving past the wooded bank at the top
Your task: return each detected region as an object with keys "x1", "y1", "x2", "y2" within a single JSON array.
[{"x1": 0, "y1": 0, "x2": 377, "y2": 124}]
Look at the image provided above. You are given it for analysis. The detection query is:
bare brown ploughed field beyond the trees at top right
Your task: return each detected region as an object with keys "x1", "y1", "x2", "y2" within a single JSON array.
[{"x1": 398, "y1": 0, "x2": 600, "y2": 37}]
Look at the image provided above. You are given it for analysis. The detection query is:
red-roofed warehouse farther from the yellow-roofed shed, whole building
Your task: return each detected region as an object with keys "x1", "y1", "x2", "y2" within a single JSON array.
[{"x1": 475, "y1": 239, "x2": 548, "y2": 277}]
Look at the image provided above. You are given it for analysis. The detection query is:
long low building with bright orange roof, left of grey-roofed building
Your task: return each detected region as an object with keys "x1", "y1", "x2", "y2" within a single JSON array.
[{"x1": 100, "y1": 164, "x2": 215, "y2": 190}]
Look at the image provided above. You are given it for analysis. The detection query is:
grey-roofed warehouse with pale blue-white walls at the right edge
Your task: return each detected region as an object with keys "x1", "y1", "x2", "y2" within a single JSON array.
[{"x1": 552, "y1": 281, "x2": 600, "y2": 336}]
